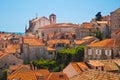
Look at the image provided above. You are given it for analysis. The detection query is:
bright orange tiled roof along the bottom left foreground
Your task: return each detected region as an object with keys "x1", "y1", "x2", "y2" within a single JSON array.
[{"x1": 8, "y1": 69, "x2": 49, "y2": 80}]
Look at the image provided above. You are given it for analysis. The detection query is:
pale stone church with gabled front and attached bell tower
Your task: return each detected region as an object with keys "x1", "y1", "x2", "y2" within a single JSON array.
[{"x1": 25, "y1": 14, "x2": 56, "y2": 34}]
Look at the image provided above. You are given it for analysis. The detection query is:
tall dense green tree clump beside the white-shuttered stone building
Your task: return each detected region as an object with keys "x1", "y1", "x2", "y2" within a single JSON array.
[{"x1": 56, "y1": 45, "x2": 84, "y2": 66}]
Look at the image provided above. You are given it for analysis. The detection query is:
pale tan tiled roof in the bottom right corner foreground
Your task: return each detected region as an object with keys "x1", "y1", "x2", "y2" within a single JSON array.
[{"x1": 70, "y1": 70, "x2": 120, "y2": 80}]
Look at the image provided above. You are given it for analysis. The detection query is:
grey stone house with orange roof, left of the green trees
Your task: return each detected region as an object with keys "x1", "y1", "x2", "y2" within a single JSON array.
[{"x1": 21, "y1": 37, "x2": 55, "y2": 61}]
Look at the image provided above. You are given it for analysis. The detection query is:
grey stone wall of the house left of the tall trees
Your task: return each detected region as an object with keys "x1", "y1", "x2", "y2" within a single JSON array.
[{"x1": 22, "y1": 44, "x2": 46, "y2": 61}]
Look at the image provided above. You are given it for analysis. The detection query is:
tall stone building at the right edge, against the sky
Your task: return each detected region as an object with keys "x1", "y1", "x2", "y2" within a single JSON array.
[{"x1": 110, "y1": 8, "x2": 120, "y2": 33}]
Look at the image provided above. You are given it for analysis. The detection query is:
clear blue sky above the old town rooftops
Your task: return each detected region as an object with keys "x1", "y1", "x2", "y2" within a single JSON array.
[{"x1": 0, "y1": 0, "x2": 120, "y2": 32}]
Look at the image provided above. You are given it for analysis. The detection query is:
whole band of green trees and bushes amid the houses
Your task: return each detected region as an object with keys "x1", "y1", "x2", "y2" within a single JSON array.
[{"x1": 33, "y1": 46, "x2": 84, "y2": 72}]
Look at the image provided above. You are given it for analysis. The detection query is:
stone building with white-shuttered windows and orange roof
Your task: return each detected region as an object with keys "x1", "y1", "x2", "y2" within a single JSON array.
[{"x1": 85, "y1": 39, "x2": 120, "y2": 60}]
